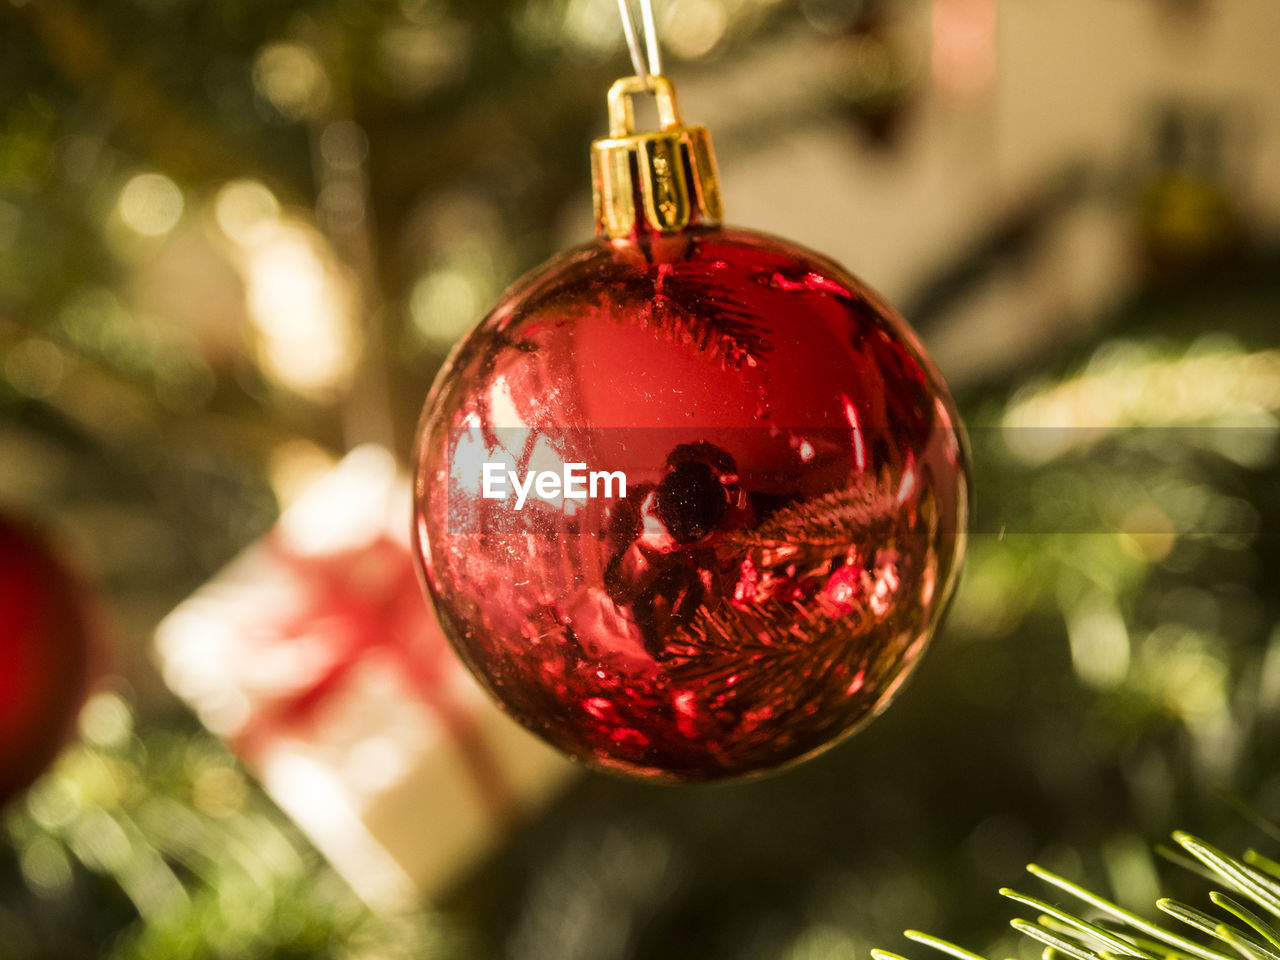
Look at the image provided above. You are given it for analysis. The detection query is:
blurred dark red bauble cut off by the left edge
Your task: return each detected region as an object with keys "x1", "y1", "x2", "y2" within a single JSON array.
[{"x1": 0, "y1": 516, "x2": 90, "y2": 804}]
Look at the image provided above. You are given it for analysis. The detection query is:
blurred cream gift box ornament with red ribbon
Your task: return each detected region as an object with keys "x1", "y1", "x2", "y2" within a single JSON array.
[{"x1": 156, "y1": 447, "x2": 576, "y2": 909}]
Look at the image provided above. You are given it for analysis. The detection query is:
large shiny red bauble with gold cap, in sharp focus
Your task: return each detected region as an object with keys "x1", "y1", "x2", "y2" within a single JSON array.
[{"x1": 415, "y1": 76, "x2": 968, "y2": 781}]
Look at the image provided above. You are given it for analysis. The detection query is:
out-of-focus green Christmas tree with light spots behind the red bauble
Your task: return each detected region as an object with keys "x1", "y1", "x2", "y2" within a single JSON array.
[{"x1": 0, "y1": 0, "x2": 1280, "y2": 960}]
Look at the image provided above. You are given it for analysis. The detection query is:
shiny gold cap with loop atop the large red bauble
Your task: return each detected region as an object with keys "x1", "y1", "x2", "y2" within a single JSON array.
[{"x1": 591, "y1": 74, "x2": 723, "y2": 239}]
